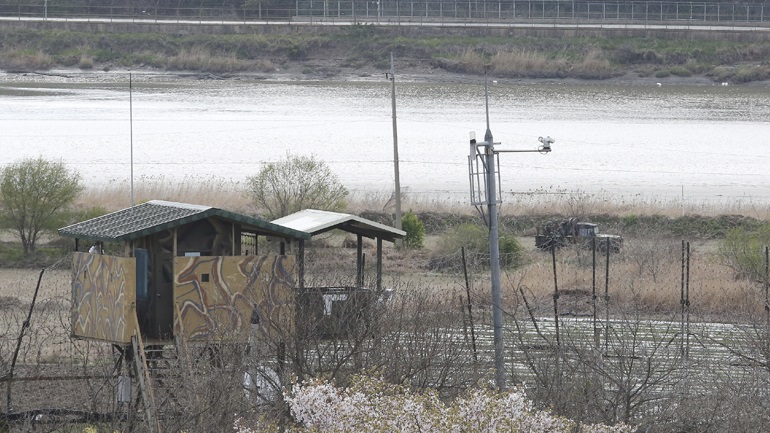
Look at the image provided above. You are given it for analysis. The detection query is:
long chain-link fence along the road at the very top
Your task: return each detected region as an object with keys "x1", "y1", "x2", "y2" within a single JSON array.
[{"x1": 0, "y1": 0, "x2": 770, "y2": 25}]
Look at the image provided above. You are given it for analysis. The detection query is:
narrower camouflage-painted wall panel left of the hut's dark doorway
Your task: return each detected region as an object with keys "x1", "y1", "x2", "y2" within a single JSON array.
[{"x1": 71, "y1": 252, "x2": 136, "y2": 344}]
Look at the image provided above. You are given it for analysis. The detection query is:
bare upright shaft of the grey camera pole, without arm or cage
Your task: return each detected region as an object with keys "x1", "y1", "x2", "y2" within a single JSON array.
[{"x1": 484, "y1": 74, "x2": 506, "y2": 391}]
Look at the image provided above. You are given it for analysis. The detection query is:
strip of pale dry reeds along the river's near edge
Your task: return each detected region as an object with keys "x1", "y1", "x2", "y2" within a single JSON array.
[{"x1": 77, "y1": 176, "x2": 770, "y2": 221}]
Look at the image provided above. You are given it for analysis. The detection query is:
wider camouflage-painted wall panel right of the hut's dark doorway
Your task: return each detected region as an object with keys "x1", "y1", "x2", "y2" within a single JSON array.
[{"x1": 174, "y1": 255, "x2": 296, "y2": 342}]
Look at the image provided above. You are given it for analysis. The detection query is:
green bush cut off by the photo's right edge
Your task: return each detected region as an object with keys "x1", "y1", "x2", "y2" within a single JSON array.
[{"x1": 719, "y1": 223, "x2": 770, "y2": 281}]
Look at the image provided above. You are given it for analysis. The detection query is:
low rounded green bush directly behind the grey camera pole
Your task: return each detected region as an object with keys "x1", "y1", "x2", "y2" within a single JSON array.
[{"x1": 429, "y1": 224, "x2": 523, "y2": 270}]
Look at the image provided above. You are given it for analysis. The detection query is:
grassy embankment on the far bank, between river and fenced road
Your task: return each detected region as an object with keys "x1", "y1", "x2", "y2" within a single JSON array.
[{"x1": 0, "y1": 26, "x2": 770, "y2": 83}]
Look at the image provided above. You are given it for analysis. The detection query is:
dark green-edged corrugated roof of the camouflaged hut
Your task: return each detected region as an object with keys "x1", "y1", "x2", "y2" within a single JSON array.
[{"x1": 59, "y1": 200, "x2": 310, "y2": 242}]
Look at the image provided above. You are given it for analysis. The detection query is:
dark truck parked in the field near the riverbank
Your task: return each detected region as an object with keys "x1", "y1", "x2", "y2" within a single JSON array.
[{"x1": 535, "y1": 218, "x2": 623, "y2": 253}]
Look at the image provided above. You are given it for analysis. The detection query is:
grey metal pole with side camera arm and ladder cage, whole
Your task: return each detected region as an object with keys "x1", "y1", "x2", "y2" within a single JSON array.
[{"x1": 468, "y1": 74, "x2": 554, "y2": 391}]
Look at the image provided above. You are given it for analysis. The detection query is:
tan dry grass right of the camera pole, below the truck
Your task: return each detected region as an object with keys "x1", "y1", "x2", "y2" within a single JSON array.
[{"x1": 503, "y1": 240, "x2": 764, "y2": 322}]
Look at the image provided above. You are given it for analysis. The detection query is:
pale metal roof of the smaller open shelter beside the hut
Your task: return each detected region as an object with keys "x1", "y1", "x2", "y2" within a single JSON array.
[{"x1": 273, "y1": 209, "x2": 406, "y2": 242}]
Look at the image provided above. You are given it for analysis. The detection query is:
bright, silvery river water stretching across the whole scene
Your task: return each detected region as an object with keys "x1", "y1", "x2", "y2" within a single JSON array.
[{"x1": 0, "y1": 73, "x2": 770, "y2": 208}]
